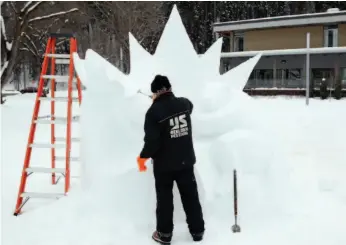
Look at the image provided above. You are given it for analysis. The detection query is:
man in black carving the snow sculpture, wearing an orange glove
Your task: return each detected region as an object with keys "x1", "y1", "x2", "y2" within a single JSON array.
[{"x1": 137, "y1": 75, "x2": 204, "y2": 244}]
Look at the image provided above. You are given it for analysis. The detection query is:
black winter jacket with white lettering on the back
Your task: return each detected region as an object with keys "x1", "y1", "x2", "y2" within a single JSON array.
[{"x1": 140, "y1": 92, "x2": 196, "y2": 172}]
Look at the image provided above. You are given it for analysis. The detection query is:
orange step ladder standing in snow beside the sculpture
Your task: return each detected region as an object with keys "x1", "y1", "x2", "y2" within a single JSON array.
[{"x1": 14, "y1": 33, "x2": 82, "y2": 216}]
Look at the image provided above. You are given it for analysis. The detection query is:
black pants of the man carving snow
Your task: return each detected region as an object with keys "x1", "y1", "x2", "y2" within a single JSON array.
[{"x1": 154, "y1": 167, "x2": 204, "y2": 234}]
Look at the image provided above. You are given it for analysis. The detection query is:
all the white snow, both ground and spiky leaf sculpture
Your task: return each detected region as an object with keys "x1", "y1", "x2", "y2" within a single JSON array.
[{"x1": 0, "y1": 4, "x2": 346, "y2": 245}]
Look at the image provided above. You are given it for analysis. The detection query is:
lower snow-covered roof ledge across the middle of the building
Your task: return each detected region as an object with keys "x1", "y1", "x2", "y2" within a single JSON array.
[{"x1": 221, "y1": 47, "x2": 346, "y2": 58}]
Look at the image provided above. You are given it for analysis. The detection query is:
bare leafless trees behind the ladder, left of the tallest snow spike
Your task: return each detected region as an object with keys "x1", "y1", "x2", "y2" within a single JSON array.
[{"x1": 1, "y1": 1, "x2": 166, "y2": 103}]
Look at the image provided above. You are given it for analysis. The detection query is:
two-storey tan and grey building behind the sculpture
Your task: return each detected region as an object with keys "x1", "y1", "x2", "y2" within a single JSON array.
[{"x1": 213, "y1": 9, "x2": 346, "y2": 94}]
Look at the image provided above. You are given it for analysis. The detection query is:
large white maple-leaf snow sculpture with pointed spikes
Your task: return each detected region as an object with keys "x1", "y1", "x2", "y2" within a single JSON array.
[{"x1": 74, "y1": 6, "x2": 261, "y2": 228}]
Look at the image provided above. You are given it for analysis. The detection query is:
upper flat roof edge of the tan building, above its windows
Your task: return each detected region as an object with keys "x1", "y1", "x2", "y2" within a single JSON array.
[{"x1": 213, "y1": 8, "x2": 346, "y2": 32}]
